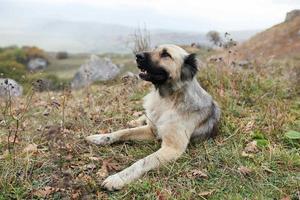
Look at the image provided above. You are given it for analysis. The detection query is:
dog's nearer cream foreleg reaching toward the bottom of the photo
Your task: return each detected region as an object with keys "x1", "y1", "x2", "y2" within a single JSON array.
[{"x1": 102, "y1": 131, "x2": 189, "y2": 191}]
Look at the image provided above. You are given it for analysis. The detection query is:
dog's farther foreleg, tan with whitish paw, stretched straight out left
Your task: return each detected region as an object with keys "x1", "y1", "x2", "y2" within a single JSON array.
[{"x1": 85, "y1": 125, "x2": 155, "y2": 145}]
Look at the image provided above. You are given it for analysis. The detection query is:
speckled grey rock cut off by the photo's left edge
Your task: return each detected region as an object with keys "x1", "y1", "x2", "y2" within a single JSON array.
[{"x1": 0, "y1": 78, "x2": 23, "y2": 97}]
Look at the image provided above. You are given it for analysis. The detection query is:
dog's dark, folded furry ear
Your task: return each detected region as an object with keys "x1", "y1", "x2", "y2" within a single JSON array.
[{"x1": 180, "y1": 53, "x2": 198, "y2": 81}]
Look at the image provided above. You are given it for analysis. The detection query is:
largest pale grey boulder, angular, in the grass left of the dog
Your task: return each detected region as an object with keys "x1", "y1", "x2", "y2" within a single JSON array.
[{"x1": 71, "y1": 55, "x2": 120, "y2": 88}]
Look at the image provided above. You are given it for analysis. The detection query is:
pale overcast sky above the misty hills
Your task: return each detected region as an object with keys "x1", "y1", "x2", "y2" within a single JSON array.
[{"x1": 0, "y1": 0, "x2": 300, "y2": 32}]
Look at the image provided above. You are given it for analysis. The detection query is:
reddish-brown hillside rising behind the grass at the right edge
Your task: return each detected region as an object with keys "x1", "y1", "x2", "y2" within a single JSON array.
[{"x1": 236, "y1": 10, "x2": 300, "y2": 60}]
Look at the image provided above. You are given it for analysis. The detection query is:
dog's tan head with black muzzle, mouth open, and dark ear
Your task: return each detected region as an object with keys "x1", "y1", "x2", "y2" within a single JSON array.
[{"x1": 136, "y1": 45, "x2": 197, "y2": 85}]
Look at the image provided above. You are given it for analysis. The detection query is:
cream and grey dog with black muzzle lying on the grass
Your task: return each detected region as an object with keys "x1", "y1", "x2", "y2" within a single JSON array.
[{"x1": 86, "y1": 45, "x2": 221, "y2": 191}]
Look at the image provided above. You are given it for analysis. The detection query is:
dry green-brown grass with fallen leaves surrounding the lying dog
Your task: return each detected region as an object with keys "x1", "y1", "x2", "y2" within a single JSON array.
[{"x1": 0, "y1": 52, "x2": 300, "y2": 199}]
